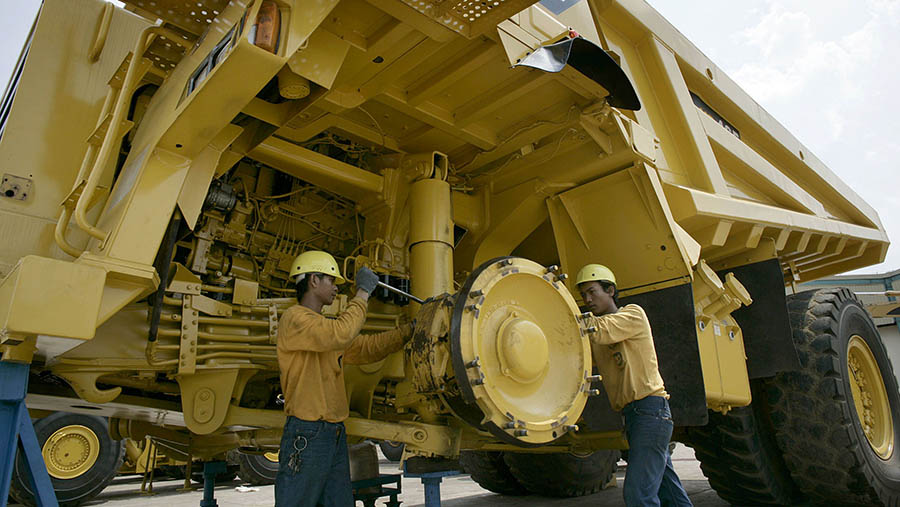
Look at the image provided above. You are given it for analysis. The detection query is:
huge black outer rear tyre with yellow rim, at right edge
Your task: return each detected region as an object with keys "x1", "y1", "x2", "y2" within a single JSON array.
[{"x1": 767, "y1": 289, "x2": 900, "y2": 505}]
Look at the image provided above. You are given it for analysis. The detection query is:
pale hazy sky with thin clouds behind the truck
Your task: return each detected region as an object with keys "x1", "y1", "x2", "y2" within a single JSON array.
[{"x1": 0, "y1": 0, "x2": 900, "y2": 273}]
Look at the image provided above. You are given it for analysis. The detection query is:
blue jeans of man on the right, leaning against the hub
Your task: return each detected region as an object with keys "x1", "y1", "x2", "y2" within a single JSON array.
[{"x1": 622, "y1": 396, "x2": 693, "y2": 507}]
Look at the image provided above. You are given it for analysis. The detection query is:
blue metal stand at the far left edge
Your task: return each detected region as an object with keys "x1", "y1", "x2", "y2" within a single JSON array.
[{"x1": 0, "y1": 361, "x2": 59, "y2": 507}]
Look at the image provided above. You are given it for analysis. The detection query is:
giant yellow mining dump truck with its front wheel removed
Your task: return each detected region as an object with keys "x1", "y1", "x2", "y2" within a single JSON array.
[{"x1": 0, "y1": 0, "x2": 900, "y2": 504}]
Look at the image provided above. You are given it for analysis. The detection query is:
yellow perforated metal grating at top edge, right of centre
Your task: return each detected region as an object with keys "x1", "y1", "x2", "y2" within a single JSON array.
[{"x1": 402, "y1": 0, "x2": 537, "y2": 38}]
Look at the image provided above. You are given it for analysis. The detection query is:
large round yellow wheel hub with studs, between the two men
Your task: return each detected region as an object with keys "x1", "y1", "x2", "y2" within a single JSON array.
[{"x1": 450, "y1": 257, "x2": 591, "y2": 446}]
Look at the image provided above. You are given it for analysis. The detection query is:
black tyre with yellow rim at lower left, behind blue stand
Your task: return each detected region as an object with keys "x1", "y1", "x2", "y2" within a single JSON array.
[{"x1": 9, "y1": 412, "x2": 125, "y2": 507}]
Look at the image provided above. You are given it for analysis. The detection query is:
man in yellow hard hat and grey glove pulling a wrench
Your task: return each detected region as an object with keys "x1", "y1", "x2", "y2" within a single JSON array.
[{"x1": 275, "y1": 251, "x2": 413, "y2": 507}]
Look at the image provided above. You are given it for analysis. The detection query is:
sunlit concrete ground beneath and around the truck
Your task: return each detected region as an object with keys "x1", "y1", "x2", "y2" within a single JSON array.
[{"x1": 24, "y1": 444, "x2": 728, "y2": 507}]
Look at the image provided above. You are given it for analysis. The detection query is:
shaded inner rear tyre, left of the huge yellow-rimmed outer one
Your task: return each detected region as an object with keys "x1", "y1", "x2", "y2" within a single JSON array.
[{"x1": 686, "y1": 402, "x2": 799, "y2": 505}]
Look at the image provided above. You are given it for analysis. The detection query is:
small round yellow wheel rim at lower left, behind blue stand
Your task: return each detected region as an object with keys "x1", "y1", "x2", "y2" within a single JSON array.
[{"x1": 41, "y1": 424, "x2": 100, "y2": 479}]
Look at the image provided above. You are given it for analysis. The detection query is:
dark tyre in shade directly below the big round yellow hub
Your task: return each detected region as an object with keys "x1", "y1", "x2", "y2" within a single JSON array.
[{"x1": 504, "y1": 450, "x2": 619, "y2": 497}]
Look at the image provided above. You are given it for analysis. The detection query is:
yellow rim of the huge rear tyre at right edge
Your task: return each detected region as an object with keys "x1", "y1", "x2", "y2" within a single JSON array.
[{"x1": 847, "y1": 335, "x2": 894, "y2": 460}]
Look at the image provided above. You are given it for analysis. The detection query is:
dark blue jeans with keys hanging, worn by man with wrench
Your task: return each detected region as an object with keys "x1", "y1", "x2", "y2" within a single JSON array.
[{"x1": 275, "y1": 416, "x2": 355, "y2": 507}]
